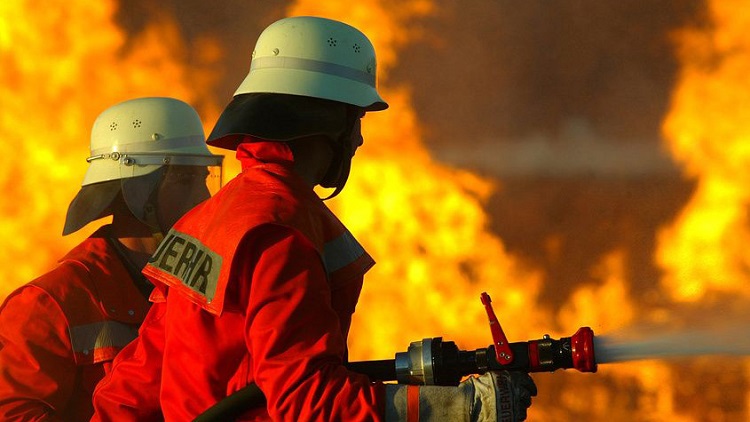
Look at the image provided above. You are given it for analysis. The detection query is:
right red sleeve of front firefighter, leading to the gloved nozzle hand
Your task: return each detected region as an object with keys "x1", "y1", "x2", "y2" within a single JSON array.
[{"x1": 237, "y1": 226, "x2": 384, "y2": 421}]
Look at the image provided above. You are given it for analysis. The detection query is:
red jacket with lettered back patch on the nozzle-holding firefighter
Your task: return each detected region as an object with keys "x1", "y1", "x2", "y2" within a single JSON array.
[{"x1": 93, "y1": 142, "x2": 384, "y2": 421}]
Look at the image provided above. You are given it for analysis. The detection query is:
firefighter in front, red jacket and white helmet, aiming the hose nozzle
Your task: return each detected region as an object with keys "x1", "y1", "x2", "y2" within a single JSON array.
[{"x1": 92, "y1": 16, "x2": 536, "y2": 421}]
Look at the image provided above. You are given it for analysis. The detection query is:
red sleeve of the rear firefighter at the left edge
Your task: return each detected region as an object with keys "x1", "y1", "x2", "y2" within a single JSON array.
[{"x1": 0, "y1": 286, "x2": 70, "y2": 421}]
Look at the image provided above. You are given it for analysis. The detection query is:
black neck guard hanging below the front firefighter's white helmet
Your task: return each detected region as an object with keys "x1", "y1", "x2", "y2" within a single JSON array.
[{"x1": 207, "y1": 93, "x2": 353, "y2": 150}]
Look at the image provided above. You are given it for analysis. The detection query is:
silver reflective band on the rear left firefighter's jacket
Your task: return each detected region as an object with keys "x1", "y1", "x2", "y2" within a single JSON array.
[{"x1": 70, "y1": 321, "x2": 138, "y2": 354}]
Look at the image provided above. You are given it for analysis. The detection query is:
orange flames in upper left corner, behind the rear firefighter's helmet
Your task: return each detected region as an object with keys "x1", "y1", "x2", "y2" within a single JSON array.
[{"x1": 0, "y1": 0, "x2": 225, "y2": 298}]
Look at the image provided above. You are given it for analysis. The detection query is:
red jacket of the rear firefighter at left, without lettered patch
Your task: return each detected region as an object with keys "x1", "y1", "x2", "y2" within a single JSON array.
[{"x1": 0, "y1": 226, "x2": 149, "y2": 421}]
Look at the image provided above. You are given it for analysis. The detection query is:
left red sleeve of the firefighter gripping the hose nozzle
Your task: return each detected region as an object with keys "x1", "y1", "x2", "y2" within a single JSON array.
[{"x1": 91, "y1": 296, "x2": 166, "y2": 422}]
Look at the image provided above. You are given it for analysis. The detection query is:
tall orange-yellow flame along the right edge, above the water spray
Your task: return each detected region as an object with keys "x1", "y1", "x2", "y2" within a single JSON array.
[{"x1": 657, "y1": 1, "x2": 750, "y2": 302}]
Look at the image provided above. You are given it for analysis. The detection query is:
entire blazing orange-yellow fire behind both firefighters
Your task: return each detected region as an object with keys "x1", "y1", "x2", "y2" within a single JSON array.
[{"x1": 0, "y1": 0, "x2": 750, "y2": 421}]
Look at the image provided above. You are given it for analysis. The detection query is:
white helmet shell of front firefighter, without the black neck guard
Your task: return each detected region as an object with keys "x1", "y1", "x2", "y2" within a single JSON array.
[{"x1": 234, "y1": 16, "x2": 388, "y2": 111}]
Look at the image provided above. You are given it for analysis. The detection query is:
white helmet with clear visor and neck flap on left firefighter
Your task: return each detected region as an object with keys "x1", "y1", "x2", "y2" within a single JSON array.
[{"x1": 63, "y1": 97, "x2": 224, "y2": 235}]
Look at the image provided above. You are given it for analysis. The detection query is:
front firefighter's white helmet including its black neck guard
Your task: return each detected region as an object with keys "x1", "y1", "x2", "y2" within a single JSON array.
[{"x1": 208, "y1": 16, "x2": 388, "y2": 149}]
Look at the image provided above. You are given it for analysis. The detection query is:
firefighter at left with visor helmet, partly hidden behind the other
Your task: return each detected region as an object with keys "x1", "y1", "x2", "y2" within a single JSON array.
[{"x1": 0, "y1": 98, "x2": 223, "y2": 421}]
